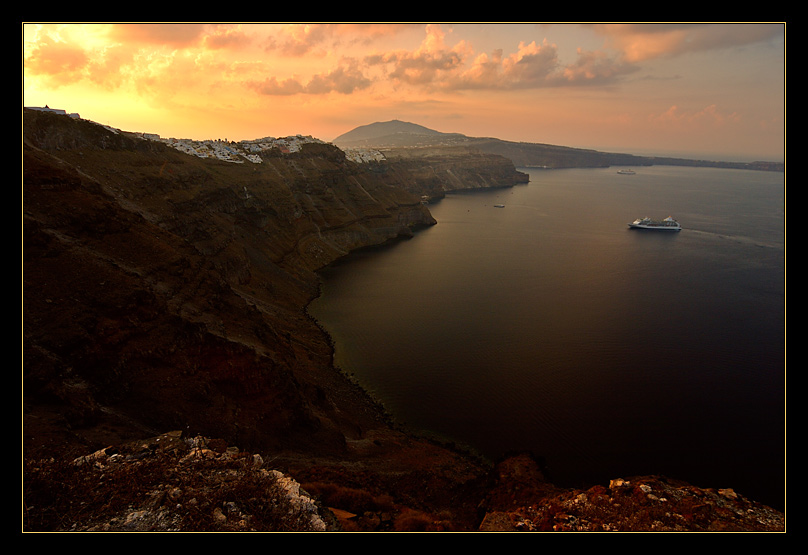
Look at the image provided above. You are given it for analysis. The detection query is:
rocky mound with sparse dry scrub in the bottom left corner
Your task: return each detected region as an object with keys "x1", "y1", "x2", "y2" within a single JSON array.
[{"x1": 23, "y1": 436, "x2": 326, "y2": 532}]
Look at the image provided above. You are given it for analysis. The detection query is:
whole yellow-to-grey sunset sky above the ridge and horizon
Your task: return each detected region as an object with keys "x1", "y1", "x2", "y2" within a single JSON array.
[{"x1": 22, "y1": 22, "x2": 786, "y2": 161}]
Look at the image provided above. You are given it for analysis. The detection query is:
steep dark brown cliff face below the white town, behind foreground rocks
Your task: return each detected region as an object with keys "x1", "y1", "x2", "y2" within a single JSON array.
[{"x1": 23, "y1": 108, "x2": 442, "y2": 460}]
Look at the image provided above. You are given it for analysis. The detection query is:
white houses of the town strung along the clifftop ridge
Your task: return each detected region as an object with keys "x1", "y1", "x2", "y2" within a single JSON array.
[{"x1": 26, "y1": 106, "x2": 384, "y2": 164}]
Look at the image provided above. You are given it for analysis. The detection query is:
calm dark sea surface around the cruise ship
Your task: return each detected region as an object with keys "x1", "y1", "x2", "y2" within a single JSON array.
[{"x1": 310, "y1": 166, "x2": 785, "y2": 508}]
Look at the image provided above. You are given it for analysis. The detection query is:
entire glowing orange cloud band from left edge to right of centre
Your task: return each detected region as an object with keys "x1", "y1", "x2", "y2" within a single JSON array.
[{"x1": 19, "y1": 24, "x2": 668, "y2": 100}]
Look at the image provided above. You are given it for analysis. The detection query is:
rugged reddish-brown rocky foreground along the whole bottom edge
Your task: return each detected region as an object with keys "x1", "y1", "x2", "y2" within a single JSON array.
[{"x1": 25, "y1": 432, "x2": 785, "y2": 532}]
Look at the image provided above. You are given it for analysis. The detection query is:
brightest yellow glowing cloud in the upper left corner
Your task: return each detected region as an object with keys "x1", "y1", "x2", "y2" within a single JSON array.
[{"x1": 23, "y1": 24, "x2": 263, "y2": 102}]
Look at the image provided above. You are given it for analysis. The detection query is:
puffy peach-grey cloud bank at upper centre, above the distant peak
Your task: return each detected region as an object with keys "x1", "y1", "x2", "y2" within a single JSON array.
[{"x1": 250, "y1": 25, "x2": 652, "y2": 96}]
